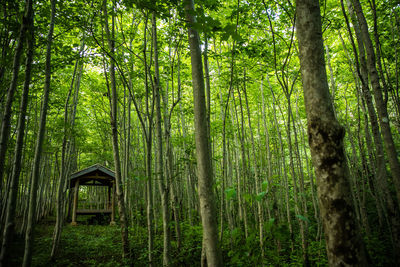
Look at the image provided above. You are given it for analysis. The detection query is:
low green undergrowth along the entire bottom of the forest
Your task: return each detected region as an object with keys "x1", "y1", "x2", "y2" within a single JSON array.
[{"x1": 7, "y1": 217, "x2": 393, "y2": 267}]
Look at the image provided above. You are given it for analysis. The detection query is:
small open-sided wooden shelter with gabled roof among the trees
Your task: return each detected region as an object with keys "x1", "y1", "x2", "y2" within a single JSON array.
[{"x1": 69, "y1": 164, "x2": 115, "y2": 225}]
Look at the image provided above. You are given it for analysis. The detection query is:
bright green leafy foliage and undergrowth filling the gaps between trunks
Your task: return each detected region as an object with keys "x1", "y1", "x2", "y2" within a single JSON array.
[{"x1": 0, "y1": 0, "x2": 399, "y2": 266}]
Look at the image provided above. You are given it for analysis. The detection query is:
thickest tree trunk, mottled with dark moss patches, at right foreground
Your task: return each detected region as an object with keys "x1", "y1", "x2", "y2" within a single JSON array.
[{"x1": 296, "y1": 0, "x2": 368, "y2": 266}]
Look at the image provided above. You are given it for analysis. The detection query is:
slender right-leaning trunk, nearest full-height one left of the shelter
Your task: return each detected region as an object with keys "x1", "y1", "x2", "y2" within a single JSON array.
[{"x1": 22, "y1": 0, "x2": 56, "y2": 267}]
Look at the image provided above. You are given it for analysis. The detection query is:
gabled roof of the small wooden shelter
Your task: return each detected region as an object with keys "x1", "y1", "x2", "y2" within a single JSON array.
[{"x1": 69, "y1": 164, "x2": 115, "y2": 188}]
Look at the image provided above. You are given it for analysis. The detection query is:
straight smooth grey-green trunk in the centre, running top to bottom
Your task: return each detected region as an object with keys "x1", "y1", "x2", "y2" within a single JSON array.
[{"x1": 184, "y1": 0, "x2": 221, "y2": 266}]
